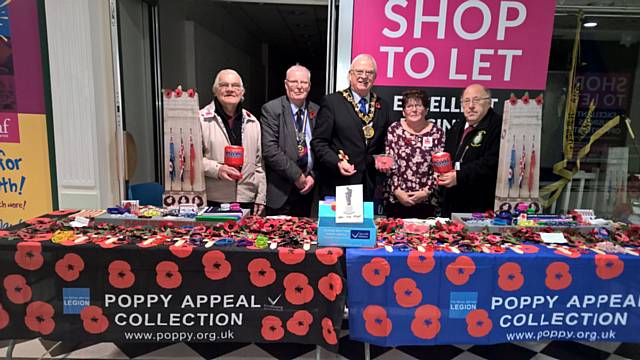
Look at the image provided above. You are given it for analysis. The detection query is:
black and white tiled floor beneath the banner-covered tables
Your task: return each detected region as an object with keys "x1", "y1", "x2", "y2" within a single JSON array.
[{"x1": 0, "y1": 336, "x2": 640, "y2": 360}]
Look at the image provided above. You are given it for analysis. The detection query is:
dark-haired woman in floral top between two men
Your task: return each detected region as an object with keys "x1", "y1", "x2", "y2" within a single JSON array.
[{"x1": 385, "y1": 90, "x2": 444, "y2": 219}]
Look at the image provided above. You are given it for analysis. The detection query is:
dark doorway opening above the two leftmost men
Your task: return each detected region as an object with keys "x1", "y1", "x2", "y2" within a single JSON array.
[{"x1": 158, "y1": 0, "x2": 327, "y2": 114}]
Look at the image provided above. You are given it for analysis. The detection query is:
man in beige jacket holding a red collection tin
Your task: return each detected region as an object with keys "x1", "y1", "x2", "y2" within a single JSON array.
[{"x1": 200, "y1": 69, "x2": 267, "y2": 215}]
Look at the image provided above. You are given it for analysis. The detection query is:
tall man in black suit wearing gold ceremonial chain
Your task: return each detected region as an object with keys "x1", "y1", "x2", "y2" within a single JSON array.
[{"x1": 311, "y1": 54, "x2": 391, "y2": 201}]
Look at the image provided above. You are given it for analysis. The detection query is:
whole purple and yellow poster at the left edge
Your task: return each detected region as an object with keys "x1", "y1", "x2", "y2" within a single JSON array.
[{"x1": 0, "y1": 0, "x2": 52, "y2": 228}]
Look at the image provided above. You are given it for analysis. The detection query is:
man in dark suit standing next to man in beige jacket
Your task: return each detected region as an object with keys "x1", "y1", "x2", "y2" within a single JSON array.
[{"x1": 260, "y1": 65, "x2": 318, "y2": 217}]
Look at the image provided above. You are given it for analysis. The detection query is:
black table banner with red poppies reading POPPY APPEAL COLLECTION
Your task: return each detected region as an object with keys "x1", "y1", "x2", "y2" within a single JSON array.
[{"x1": 0, "y1": 232, "x2": 346, "y2": 351}]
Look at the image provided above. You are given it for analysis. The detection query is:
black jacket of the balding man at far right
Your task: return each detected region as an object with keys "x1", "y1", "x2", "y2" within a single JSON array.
[{"x1": 442, "y1": 108, "x2": 502, "y2": 217}]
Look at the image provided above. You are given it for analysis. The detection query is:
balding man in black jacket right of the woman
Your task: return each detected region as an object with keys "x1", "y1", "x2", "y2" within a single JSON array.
[{"x1": 438, "y1": 84, "x2": 502, "y2": 217}]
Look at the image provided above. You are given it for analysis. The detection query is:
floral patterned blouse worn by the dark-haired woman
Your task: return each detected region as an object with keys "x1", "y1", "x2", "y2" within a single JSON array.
[{"x1": 385, "y1": 121, "x2": 444, "y2": 204}]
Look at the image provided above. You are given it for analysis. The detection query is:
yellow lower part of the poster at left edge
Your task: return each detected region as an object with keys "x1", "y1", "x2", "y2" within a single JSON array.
[{"x1": 0, "y1": 114, "x2": 52, "y2": 228}]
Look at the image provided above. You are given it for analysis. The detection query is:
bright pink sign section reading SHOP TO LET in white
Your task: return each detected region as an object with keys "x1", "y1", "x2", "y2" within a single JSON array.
[{"x1": 351, "y1": 0, "x2": 555, "y2": 90}]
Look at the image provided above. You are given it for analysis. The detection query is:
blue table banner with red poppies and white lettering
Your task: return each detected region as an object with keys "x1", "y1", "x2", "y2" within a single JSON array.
[{"x1": 347, "y1": 245, "x2": 640, "y2": 346}]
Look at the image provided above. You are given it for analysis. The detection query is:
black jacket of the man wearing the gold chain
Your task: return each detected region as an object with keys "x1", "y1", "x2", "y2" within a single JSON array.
[{"x1": 311, "y1": 92, "x2": 391, "y2": 201}]
